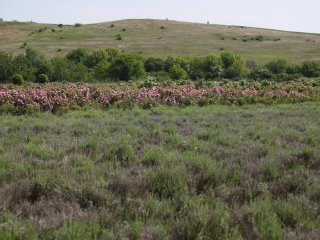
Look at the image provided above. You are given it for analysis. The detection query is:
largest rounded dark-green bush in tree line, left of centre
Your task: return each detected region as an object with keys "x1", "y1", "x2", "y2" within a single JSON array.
[{"x1": 108, "y1": 54, "x2": 145, "y2": 81}]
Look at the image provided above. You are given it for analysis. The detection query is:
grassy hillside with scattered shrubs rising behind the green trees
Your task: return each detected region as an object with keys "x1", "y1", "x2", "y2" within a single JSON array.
[{"x1": 0, "y1": 20, "x2": 320, "y2": 64}]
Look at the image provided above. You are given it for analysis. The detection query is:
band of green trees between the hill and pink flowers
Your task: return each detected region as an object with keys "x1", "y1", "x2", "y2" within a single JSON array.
[{"x1": 0, "y1": 48, "x2": 320, "y2": 84}]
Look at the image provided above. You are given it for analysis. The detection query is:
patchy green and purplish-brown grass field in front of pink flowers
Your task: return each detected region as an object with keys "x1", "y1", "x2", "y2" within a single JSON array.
[{"x1": 0, "y1": 103, "x2": 320, "y2": 239}]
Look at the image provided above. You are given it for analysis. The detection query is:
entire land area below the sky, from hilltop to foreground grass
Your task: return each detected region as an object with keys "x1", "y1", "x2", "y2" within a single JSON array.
[{"x1": 0, "y1": 20, "x2": 320, "y2": 240}]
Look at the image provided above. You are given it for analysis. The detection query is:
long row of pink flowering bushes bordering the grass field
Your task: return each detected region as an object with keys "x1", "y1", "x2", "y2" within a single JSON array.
[{"x1": 0, "y1": 84, "x2": 320, "y2": 114}]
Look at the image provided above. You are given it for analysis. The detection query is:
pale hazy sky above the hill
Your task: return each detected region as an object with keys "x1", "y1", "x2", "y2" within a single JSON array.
[{"x1": 0, "y1": 0, "x2": 320, "y2": 33}]
